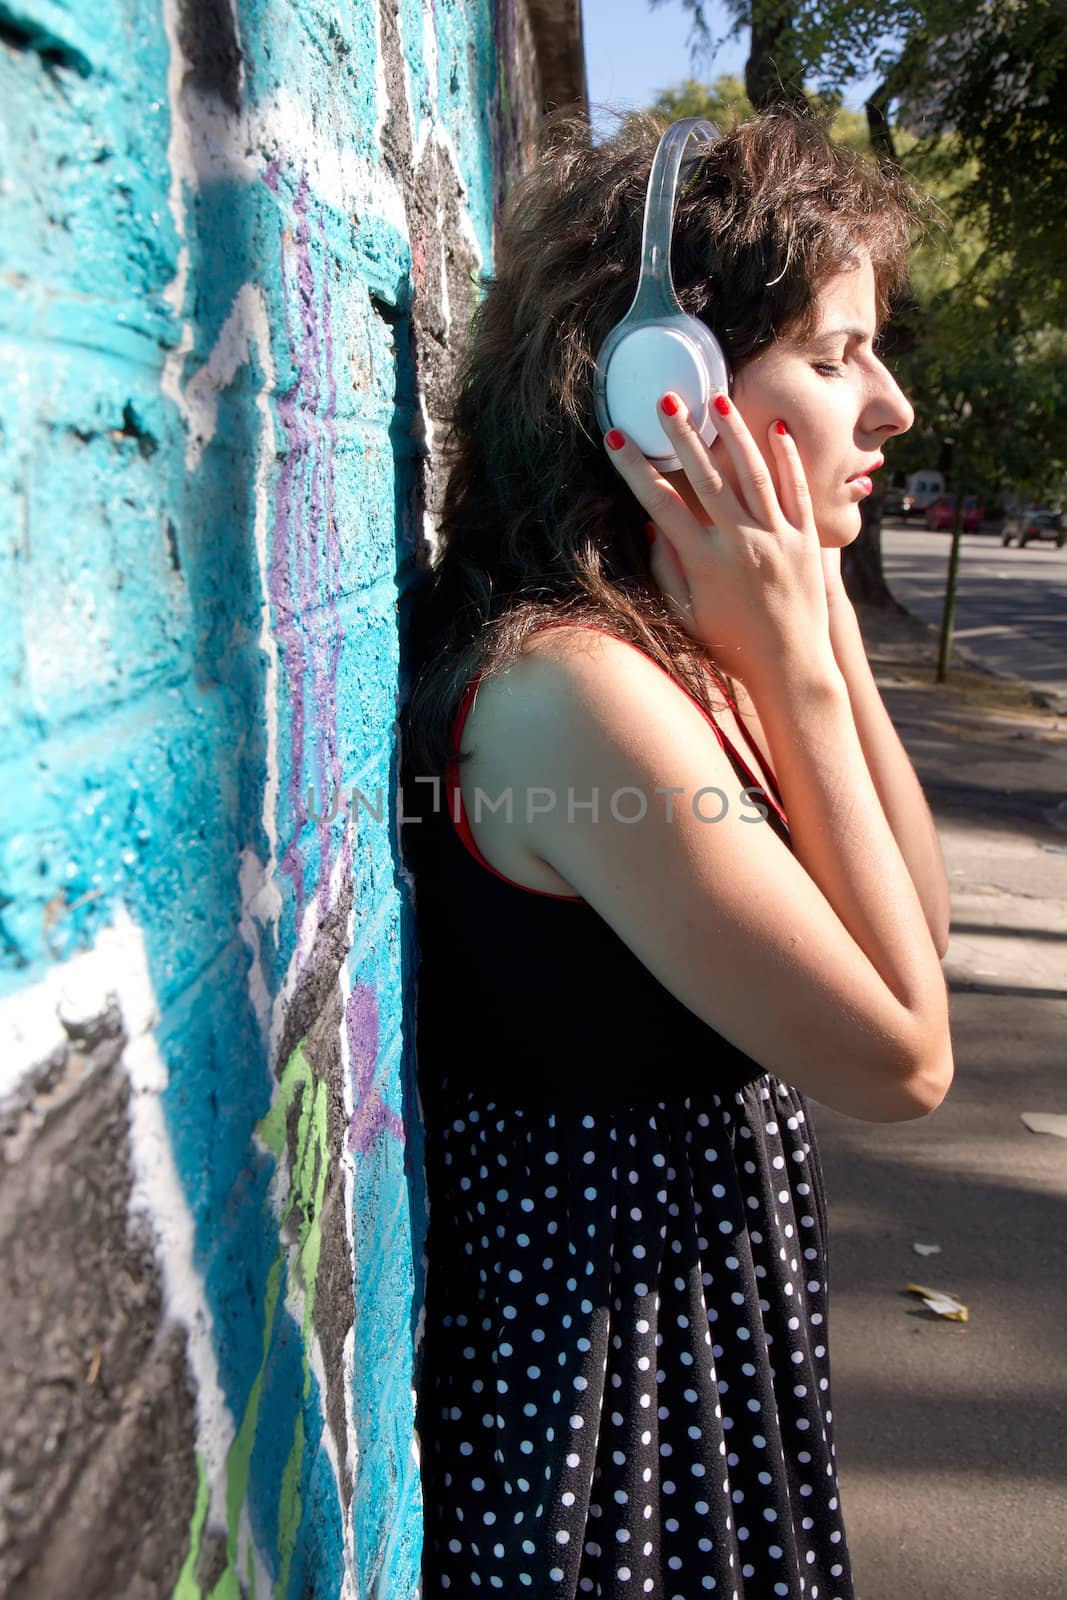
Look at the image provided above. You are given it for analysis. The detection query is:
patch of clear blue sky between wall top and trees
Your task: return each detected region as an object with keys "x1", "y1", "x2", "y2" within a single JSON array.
[{"x1": 581, "y1": 0, "x2": 875, "y2": 134}]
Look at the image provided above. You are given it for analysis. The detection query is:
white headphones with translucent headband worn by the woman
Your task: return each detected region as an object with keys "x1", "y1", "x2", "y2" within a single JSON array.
[{"x1": 593, "y1": 117, "x2": 729, "y2": 472}]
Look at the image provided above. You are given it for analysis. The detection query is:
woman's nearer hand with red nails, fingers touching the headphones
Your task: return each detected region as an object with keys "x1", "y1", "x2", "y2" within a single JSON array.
[{"x1": 608, "y1": 395, "x2": 833, "y2": 683}]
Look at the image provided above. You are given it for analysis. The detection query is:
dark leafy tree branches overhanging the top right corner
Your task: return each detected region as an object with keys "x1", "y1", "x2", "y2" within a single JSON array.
[{"x1": 671, "y1": 0, "x2": 1067, "y2": 323}]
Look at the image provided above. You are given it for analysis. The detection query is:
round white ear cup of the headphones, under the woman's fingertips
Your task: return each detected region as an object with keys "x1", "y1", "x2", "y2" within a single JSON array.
[{"x1": 605, "y1": 317, "x2": 729, "y2": 472}]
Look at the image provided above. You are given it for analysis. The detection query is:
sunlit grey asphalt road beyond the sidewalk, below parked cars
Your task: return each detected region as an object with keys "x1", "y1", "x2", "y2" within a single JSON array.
[{"x1": 881, "y1": 522, "x2": 1067, "y2": 710}]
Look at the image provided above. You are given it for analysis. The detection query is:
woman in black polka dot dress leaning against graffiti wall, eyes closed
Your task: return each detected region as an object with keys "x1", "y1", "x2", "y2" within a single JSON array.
[{"x1": 403, "y1": 103, "x2": 952, "y2": 1600}]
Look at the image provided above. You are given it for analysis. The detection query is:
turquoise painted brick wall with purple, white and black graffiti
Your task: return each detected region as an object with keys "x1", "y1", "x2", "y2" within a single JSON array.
[{"x1": 0, "y1": 0, "x2": 582, "y2": 1600}]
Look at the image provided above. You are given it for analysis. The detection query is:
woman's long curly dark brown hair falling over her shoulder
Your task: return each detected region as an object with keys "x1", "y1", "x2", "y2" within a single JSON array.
[{"x1": 402, "y1": 98, "x2": 921, "y2": 774}]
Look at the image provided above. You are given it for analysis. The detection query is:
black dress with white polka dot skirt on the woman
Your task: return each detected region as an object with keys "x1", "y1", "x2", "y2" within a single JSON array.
[{"x1": 413, "y1": 624, "x2": 854, "y2": 1600}]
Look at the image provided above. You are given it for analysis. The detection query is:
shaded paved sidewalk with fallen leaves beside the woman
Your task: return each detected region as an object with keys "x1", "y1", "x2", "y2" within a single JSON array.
[{"x1": 814, "y1": 610, "x2": 1067, "y2": 1600}]
